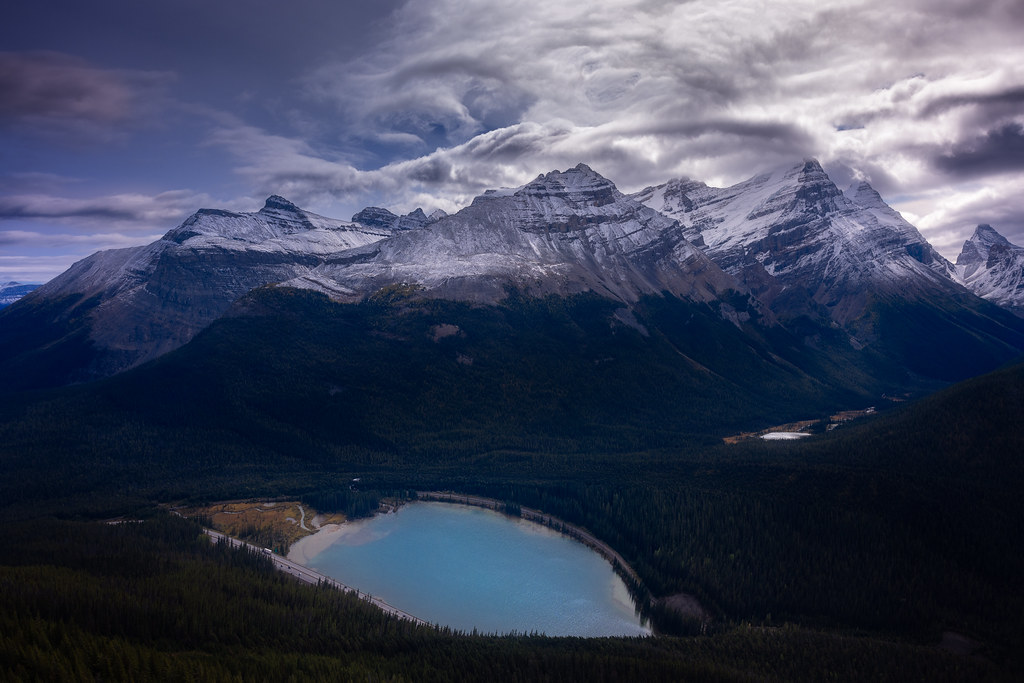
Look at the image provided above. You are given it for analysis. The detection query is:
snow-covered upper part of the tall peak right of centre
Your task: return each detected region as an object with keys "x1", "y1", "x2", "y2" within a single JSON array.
[{"x1": 635, "y1": 160, "x2": 952, "y2": 280}]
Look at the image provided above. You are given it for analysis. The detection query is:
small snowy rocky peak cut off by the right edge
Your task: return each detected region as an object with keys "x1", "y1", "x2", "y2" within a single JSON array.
[{"x1": 956, "y1": 224, "x2": 1024, "y2": 316}]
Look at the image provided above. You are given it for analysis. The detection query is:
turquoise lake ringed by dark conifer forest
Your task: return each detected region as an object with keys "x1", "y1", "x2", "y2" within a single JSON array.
[{"x1": 290, "y1": 503, "x2": 649, "y2": 637}]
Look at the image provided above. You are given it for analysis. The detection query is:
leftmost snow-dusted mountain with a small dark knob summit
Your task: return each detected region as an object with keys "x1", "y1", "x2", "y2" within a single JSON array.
[{"x1": 18, "y1": 196, "x2": 392, "y2": 374}]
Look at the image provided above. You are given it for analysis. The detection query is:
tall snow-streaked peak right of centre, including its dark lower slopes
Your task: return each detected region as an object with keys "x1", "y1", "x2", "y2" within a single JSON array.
[{"x1": 634, "y1": 159, "x2": 951, "y2": 325}]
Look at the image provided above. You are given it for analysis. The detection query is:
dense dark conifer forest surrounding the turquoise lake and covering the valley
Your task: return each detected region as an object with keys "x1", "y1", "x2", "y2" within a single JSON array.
[{"x1": 0, "y1": 291, "x2": 1024, "y2": 681}]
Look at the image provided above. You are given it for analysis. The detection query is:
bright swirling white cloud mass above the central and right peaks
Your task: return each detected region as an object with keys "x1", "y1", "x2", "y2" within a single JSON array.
[{"x1": 272, "y1": 0, "x2": 1024, "y2": 244}]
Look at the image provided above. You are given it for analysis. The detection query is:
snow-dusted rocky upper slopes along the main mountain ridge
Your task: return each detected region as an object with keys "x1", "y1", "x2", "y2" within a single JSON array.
[{"x1": 25, "y1": 160, "x2": 983, "y2": 325}]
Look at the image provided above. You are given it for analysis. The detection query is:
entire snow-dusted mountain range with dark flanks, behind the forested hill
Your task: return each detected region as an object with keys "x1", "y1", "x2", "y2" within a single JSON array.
[{"x1": 0, "y1": 160, "x2": 1024, "y2": 390}]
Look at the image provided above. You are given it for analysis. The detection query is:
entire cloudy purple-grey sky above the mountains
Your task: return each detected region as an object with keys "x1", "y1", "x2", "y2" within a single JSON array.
[{"x1": 0, "y1": 0, "x2": 1024, "y2": 282}]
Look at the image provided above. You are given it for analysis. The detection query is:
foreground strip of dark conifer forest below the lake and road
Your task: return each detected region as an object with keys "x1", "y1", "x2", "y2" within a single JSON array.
[{"x1": 0, "y1": 514, "x2": 998, "y2": 681}]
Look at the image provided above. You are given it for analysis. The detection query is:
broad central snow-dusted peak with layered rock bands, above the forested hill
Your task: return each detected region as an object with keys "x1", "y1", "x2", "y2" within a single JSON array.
[{"x1": 288, "y1": 164, "x2": 742, "y2": 302}]
